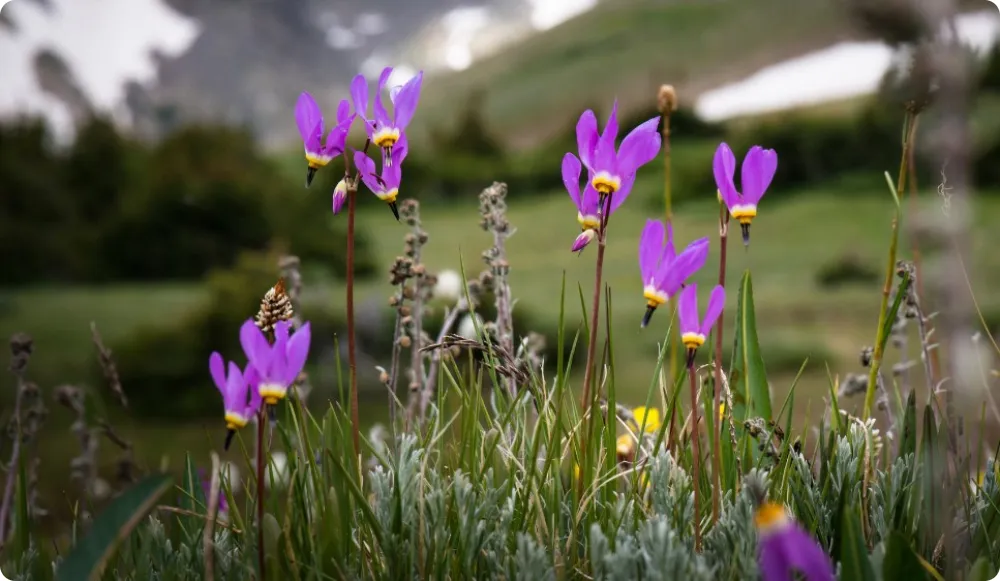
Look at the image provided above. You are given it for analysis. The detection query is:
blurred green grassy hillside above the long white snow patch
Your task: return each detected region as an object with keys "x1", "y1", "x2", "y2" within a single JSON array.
[{"x1": 421, "y1": 0, "x2": 858, "y2": 144}]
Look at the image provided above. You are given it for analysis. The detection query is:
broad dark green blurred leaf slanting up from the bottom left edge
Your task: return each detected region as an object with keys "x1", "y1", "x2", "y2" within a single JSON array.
[{"x1": 56, "y1": 474, "x2": 173, "y2": 581}]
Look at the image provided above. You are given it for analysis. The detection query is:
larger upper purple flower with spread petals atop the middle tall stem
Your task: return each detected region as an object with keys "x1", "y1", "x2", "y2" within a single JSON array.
[{"x1": 576, "y1": 101, "x2": 660, "y2": 201}]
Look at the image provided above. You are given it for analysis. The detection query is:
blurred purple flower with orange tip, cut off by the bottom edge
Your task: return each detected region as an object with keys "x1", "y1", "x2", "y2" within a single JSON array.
[{"x1": 754, "y1": 502, "x2": 834, "y2": 581}]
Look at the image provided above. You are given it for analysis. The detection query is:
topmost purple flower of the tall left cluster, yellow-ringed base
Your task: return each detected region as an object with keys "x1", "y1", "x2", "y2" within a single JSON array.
[{"x1": 351, "y1": 67, "x2": 424, "y2": 164}]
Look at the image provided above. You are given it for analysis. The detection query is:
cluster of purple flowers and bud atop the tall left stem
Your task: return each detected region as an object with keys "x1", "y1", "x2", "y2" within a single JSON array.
[{"x1": 295, "y1": 67, "x2": 423, "y2": 220}]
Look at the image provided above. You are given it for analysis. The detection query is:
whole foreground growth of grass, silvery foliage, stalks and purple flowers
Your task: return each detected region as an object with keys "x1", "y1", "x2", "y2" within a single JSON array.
[{"x1": 0, "y1": 3, "x2": 1000, "y2": 581}]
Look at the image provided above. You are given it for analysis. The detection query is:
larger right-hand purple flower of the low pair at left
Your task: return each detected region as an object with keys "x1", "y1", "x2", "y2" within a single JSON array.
[{"x1": 240, "y1": 319, "x2": 310, "y2": 405}]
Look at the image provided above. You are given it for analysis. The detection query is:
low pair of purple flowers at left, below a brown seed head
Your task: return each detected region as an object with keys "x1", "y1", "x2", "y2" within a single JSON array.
[{"x1": 208, "y1": 319, "x2": 311, "y2": 449}]
